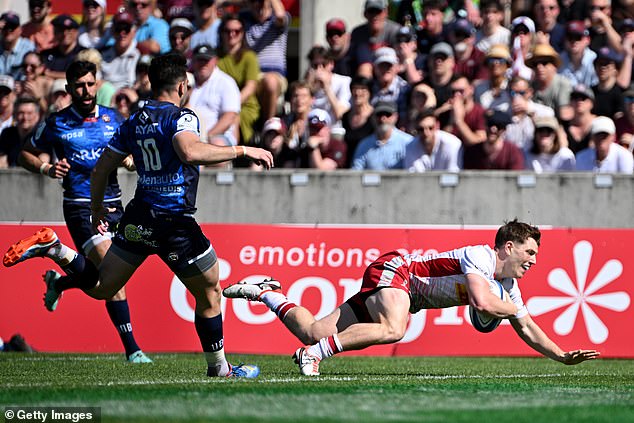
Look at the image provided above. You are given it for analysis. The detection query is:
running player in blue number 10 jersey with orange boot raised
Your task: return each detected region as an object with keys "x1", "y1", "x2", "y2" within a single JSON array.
[{"x1": 3, "y1": 54, "x2": 273, "y2": 378}]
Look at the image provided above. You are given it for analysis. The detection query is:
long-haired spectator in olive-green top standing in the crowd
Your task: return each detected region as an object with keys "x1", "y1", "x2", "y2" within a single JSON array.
[{"x1": 218, "y1": 14, "x2": 260, "y2": 144}]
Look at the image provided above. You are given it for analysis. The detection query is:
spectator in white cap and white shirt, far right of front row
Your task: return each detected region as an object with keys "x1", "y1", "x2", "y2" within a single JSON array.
[{"x1": 577, "y1": 116, "x2": 634, "y2": 175}]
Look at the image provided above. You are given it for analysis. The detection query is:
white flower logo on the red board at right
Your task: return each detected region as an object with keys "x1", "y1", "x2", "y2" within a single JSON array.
[{"x1": 526, "y1": 241, "x2": 630, "y2": 344}]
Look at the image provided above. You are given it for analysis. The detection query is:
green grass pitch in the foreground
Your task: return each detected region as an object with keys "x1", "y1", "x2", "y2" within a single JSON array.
[{"x1": 0, "y1": 353, "x2": 634, "y2": 423}]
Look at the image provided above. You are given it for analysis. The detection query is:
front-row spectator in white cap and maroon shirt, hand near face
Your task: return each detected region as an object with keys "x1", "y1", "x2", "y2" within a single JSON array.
[{"x1": 300, "y1": 109, "x2": 347, "y2": 170}]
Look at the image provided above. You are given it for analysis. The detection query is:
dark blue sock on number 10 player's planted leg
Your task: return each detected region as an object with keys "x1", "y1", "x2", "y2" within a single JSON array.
[{"x1": 194, "y1": 314, "x2": 229, "y2": 376}]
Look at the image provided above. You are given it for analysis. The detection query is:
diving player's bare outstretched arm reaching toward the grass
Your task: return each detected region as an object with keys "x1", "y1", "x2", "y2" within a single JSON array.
[{"x1": 509, "y1": 315, "x2": 600, "y2": 365}]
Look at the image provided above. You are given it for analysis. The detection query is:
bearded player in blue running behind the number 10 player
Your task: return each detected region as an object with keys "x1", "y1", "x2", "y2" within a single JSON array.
[{"x1": 18, "y1": 61, "x2": 151, "y2": 363}]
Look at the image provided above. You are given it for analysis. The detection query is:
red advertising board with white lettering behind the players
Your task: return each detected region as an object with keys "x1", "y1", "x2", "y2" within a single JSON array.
[{"x1": 0, "y1": 224, "x2": 634, "y2": 357}]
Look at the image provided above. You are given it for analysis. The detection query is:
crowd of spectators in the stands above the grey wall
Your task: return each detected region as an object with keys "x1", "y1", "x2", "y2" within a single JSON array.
[{"x1": 0, "y1": 0, "x2": 634, "y2": 174}]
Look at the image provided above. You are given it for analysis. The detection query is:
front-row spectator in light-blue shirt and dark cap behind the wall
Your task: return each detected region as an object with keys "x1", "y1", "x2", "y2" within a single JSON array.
[{"x1": 351, "y1": 101, "x2": 414, "y2": 170}]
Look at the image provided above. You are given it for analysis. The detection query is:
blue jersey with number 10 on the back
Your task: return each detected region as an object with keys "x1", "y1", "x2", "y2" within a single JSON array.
[{"x1": 109, "y1": 100, "x2": 200, "y2": 215}]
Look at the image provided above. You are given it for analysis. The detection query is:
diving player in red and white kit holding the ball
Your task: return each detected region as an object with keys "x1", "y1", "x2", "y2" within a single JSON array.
[{"x1": 223, "y1": 219, "x2": 599, "y2": 376}]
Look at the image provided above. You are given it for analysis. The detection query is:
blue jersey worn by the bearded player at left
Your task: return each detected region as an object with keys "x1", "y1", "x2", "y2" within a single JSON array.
[{"x1": 31, "y1": 105, "x2": 123, "y2": 202}]
